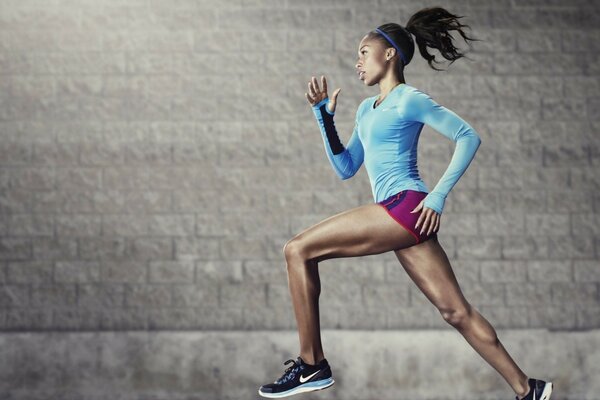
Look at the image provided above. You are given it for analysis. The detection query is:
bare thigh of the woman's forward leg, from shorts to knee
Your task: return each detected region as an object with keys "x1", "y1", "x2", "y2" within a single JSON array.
[{"x1": 285, "y1": 203, "x2": 416, "y2": 261}]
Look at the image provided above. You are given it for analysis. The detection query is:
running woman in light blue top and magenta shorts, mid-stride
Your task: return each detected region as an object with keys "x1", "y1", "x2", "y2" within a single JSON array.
[{"x1": 258, "y1": 7, "x2": 552, "y2": 400}]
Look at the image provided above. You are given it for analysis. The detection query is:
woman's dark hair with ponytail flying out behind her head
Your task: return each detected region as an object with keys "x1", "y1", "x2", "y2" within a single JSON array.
[{"x1": 374, "y1": 7, "x2": 480, "y2": 71}]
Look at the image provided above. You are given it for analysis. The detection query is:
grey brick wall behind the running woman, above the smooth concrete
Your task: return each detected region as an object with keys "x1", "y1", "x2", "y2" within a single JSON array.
[{"x1": 0, "y1": 0, "x2": 600, "y2": 331}]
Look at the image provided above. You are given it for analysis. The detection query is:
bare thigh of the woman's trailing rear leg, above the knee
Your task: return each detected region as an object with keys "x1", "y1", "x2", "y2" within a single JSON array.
[{"x1": 394, "y1": 237, "x2": 469, "y2": 314}]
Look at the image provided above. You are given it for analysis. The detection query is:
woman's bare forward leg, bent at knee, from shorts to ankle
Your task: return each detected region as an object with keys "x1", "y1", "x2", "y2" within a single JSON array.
[{"x1": 284, "y1": 203, "x2": 416, "y2": 364}]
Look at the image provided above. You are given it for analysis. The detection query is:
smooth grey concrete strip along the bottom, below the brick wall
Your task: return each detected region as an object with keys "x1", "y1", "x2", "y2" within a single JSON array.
[{"x1": 0, "y1": 330, "x2": 600, "y2": 400}]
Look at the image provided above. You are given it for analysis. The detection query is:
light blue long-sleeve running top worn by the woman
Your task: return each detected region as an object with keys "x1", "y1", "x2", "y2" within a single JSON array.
[{"x1": 312, "y1": 83, "x2": 481, "y2": 214}]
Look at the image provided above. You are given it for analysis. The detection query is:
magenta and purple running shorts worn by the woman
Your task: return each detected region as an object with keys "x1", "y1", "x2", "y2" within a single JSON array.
[{"x1": 377, "y1": 190, "x2": 437, "y2": 243}]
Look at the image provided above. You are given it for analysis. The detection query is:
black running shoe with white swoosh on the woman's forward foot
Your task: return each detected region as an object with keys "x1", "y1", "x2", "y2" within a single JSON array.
[{"x1": 258, "y1": 357, "x2": 334, "y2": 398}]
